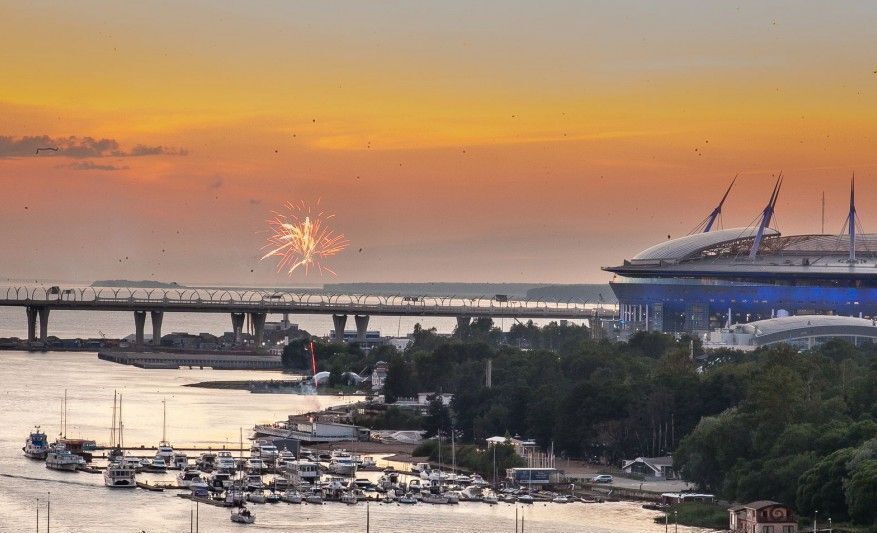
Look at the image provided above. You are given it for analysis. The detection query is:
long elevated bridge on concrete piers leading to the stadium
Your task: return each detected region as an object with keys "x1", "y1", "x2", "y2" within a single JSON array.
[{"x1": 0, "y1": 286, "x2": 616, "y2": 346}]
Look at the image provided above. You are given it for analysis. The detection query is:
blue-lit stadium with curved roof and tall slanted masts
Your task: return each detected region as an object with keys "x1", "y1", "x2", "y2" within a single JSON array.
[{"x1": 604, "y1": 176, "x2": 877, "y2": 336}]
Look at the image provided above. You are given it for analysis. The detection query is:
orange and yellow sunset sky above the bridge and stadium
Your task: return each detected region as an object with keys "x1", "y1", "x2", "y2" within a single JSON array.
[{"x1": 0, "y1": 0, "x2": 877, "y2": 285}]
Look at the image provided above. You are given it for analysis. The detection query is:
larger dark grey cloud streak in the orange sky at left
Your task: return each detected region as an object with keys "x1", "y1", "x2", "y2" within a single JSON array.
[{"x1": 0, "y1": 135, "x2": 189, "y2": 158}]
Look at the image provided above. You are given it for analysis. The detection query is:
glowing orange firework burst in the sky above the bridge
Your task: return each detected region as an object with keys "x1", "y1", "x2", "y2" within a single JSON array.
[{"x1": 262, "y1": 200, "x2": 350, "y2": 275}]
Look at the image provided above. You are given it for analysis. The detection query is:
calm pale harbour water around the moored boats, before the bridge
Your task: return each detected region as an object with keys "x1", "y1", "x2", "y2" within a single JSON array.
[{"x1": 0, "y1": 352, "x2": 704, "y2": 533}]
